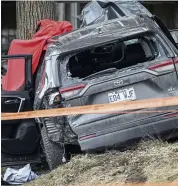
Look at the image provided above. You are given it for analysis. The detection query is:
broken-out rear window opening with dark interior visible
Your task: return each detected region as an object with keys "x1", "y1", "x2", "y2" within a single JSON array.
[{"x1": 60, "y1": 33, "x2": 165, "y2": 79}]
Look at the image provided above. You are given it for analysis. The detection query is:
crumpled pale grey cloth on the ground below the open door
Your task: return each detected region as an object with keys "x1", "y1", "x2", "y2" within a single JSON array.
[{"x1": 3, "y1": 164, "x2": 38, "y2": 185}]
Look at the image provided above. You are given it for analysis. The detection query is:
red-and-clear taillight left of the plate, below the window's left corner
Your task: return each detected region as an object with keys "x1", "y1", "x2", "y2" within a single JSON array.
[{"x1": 59, "y1": 84, "x2": 86, "y2": 98}]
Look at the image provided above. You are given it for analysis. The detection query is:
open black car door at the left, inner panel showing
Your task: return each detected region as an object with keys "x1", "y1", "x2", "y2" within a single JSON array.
[{"x1": 1, "y1": 55, "x2": 40, "y2": 166}]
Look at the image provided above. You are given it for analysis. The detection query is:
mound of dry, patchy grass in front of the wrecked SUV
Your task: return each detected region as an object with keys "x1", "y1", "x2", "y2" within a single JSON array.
[{"x1": 25, "y1": 141, "x2": 178, "y2": 186}]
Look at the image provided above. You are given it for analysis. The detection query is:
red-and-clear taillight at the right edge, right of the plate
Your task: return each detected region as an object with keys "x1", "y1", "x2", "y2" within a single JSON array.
[{"x1": 148, "y1": 59, "x2": 178, "y2": 72}]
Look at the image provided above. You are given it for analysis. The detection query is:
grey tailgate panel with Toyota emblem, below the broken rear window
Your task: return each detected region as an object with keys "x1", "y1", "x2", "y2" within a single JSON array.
[{"x1": 61, "y1": 62, "x2": 178, "y2": 132}]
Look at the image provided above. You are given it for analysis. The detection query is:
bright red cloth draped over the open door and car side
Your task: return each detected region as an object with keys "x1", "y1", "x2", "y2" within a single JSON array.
[{"x1": 2, "y1": 19, "x2": 73, "y2": 91}]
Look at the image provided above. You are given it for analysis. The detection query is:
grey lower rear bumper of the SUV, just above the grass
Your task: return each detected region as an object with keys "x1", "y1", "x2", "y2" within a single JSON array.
[{"x1": 79, "y1": 117, "x2": 178, "y2": 151}]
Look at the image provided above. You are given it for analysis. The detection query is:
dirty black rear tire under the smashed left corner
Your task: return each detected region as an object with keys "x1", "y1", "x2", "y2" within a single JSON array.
[{"x1": 41, "y1": 126, "x2": 64, "y2": 170}]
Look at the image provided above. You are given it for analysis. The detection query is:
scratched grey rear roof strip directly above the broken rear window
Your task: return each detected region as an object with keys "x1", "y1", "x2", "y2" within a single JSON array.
[{"x1": 49, "y1": 16, "x2": 156, "y2": 53}]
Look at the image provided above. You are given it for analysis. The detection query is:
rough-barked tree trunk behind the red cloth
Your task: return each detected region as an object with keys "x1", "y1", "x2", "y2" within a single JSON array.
[{"x1": 16, "y1": 1, "x2": 55, "y2": 39}]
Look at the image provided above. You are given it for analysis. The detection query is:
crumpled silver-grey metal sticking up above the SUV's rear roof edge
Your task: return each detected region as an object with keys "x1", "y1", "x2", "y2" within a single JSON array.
[{"x1": 80, "y1": 0, "x2": 152, "y2": 27}]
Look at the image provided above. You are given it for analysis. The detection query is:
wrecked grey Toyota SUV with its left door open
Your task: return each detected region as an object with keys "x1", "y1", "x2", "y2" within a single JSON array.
[{"x1": 1, "y1": 1, "x2": 178, "y2": 169}]
